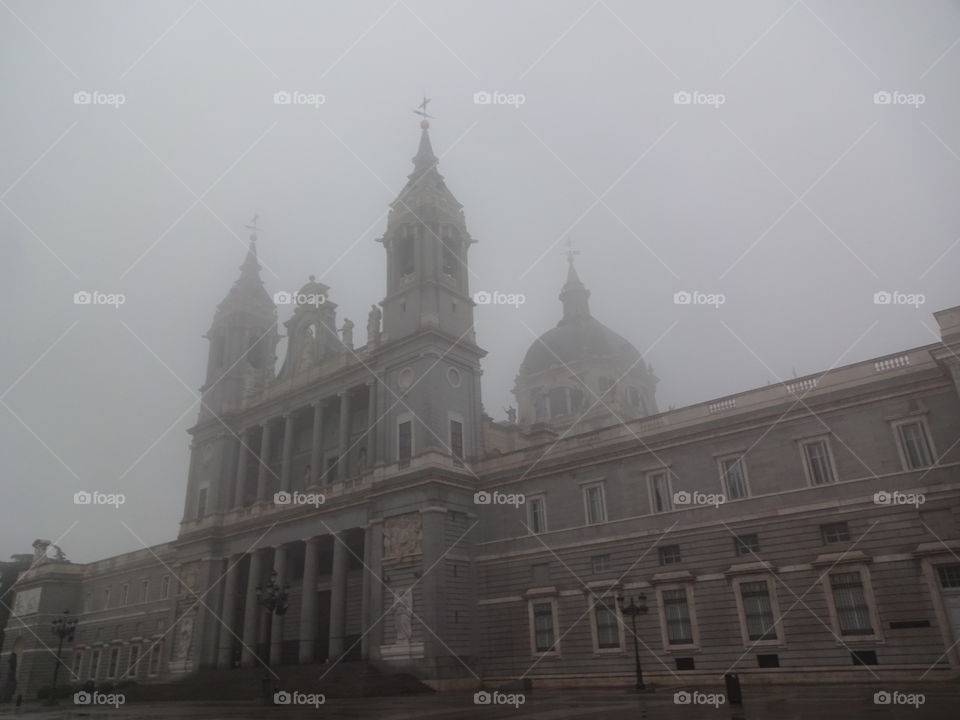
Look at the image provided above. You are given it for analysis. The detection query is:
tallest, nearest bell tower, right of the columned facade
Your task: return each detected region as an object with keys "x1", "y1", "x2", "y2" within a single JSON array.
[{"x1": 378, "y1": 104, "x2": 486, "y2": 468}]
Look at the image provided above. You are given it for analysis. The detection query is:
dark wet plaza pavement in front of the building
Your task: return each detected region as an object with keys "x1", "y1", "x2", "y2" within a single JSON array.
[{"x1": 0, "y1": 683, "x2": 960, "y2": 720}]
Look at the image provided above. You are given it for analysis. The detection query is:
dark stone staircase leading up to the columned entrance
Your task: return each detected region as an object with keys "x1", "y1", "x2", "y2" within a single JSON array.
[{"x1": 123, "y1": 661, "x2": 433, "y2": 702}]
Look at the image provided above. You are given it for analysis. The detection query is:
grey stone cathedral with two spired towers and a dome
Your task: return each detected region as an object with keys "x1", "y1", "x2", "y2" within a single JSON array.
[{"x1": 0, "y1": 119, "x2": 960, "y2": 697}]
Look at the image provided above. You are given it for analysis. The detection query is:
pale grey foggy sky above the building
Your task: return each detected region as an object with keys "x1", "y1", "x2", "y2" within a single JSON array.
[{"x1": 0, "y1": 0, "x2": 960, "y2": 562}]
